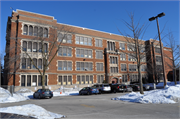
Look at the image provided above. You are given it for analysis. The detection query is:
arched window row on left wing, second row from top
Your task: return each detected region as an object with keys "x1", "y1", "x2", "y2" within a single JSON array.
[{"x1": 22, "y1": 41, "x2": 48, "y2": 52}]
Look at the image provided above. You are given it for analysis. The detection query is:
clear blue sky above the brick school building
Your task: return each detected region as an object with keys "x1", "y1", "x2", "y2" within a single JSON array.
[{"x1": 0, "y1": 1, "x2": 180, "y2": 57}]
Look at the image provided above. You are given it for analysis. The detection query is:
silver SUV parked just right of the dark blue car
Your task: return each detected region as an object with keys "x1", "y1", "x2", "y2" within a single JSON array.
[{"x1": 92, "y1": 84, "x2": 111, "y2": 94}]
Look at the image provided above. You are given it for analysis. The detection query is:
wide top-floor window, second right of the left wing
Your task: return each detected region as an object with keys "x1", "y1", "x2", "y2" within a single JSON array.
[{"x1": 75, "y1": 36, "x2": 92, "y2": 46}]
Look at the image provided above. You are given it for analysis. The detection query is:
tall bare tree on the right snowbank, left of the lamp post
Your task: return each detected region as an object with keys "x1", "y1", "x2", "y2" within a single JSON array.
[{"x1": 118, "y1": 13, "x2": 162, "y2": 94}]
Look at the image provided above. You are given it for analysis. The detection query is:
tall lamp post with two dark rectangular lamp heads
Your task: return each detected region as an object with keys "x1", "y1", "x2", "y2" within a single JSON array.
[{"x1": 149, "y1": 12, "x2": 166, "y2": 87}]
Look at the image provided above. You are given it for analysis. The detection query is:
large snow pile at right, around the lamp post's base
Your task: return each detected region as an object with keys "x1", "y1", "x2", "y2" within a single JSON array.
[{"x1": 112, "y1": 85, "x2": 180, "y2": 104}]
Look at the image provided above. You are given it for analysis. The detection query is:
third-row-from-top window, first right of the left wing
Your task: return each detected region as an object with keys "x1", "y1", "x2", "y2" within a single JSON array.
[{"x1": 58, "y1": 61, "x2": 72, "y2": 71}]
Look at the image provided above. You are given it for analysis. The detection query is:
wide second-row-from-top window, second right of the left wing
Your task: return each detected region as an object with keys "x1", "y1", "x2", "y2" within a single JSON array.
[{"x1": 76, "y1": 48, "x2": 92, "y2": 58}]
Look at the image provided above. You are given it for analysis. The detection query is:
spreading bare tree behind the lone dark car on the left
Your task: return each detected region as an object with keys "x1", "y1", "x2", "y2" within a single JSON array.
[{"x1": 6, "y1": 19, "x2": 73, "y2": 89}]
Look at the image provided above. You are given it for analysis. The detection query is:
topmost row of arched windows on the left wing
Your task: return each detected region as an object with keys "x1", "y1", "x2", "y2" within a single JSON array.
[{"x1": 23, "y1": 24, "x2": 48, "y2": 37}]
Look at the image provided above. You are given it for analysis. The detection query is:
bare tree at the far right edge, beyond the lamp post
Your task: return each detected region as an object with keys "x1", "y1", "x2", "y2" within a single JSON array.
[{"x1": 164, "y1": 31, "x2": 180, "y2": 85}]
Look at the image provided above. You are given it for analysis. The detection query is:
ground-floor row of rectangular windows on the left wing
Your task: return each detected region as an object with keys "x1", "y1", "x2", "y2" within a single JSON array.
[{"x1": 21, "y1": 75, "x2": 47, "y2": 86}]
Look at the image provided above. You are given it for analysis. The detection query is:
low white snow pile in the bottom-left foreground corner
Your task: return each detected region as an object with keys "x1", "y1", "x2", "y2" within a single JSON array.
[{"x1": 0, "y1": 104, "x2": 65, "y2": 119}]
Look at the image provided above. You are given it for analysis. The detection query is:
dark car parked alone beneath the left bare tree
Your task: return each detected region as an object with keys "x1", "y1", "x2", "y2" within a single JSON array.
[{"x1": 33, "y1": 89, "x2": 53, "y2": 99}]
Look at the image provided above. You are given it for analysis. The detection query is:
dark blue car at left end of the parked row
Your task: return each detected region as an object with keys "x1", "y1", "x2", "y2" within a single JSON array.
[{"x1": 79, "y1": 87, "x2": 99, "y2": 95}]
